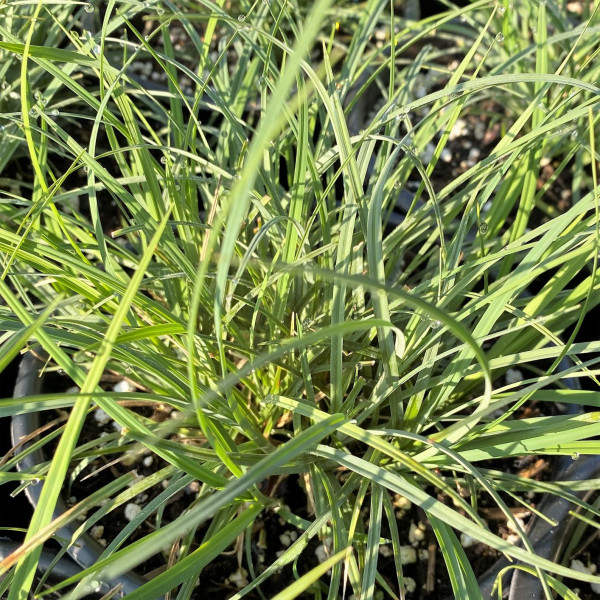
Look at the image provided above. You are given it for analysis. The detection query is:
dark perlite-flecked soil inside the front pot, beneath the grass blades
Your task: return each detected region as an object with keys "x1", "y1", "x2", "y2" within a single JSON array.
[{"x1": 8, "y1": 360, "x2": 572, "y2": 600}]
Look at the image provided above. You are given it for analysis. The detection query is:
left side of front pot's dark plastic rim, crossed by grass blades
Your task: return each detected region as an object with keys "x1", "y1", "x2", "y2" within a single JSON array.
[{"x1": 11, "y1": 353, "x2": 149, "y2": 600}]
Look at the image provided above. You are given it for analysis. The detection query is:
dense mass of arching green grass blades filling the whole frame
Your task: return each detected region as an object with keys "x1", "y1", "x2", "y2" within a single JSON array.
[{"x1": 0, "y1": 0, "x2": 600, "y2": 600}]
